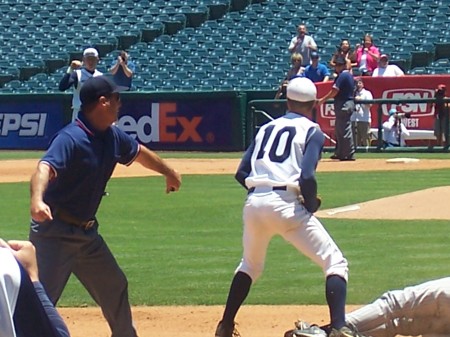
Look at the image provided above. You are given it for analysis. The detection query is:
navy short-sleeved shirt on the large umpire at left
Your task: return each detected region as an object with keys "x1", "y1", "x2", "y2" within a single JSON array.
[{"x1": 41, "y1": 113, "x2": 139, "y2": 221}]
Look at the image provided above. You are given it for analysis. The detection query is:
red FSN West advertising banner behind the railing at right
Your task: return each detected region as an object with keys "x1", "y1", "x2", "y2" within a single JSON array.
[{"x1": 316, "y1": 75, "x2": 450, "y2": 145}]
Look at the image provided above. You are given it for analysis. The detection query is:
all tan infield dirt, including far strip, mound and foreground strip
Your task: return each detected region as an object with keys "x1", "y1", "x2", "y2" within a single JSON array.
[{"x1": 0, "y1": 159, "x2": 450, "y2": 337}]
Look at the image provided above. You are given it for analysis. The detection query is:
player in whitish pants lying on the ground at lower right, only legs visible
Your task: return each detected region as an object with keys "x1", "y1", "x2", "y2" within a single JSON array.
[{"x1": 295, "y1": 277, "x2": 450, "y2": 337}]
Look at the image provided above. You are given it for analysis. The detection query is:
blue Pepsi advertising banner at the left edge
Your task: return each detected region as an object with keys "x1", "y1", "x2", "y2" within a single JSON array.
[{"x1": 0, "y1": 96, "x2": 63, "y2": 150}]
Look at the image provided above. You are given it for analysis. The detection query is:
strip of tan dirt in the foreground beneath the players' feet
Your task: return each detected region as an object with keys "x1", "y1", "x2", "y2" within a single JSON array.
[{"x1": 59, "y1": 305, "x2": 358, "y2": 337}]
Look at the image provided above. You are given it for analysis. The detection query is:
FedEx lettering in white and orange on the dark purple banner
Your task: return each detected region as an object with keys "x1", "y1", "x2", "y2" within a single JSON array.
[{"x1": 117, "y1": 103, "x2": 203, "y2": 143}]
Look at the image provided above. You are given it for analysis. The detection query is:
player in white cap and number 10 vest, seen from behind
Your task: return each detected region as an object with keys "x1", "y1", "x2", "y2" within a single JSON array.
[{"x1": 215, "y1": 78, "x2": 362, "y2": 337}]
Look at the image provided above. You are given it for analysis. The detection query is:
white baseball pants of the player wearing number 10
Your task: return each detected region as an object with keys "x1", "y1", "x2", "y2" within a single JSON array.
[{"x1": 236, "y1": 187, "x2": 348, "y2": 282}]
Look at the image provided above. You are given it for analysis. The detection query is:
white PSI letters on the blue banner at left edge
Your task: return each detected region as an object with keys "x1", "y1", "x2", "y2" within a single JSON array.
[{"x1": 0, "y1": 112, "x2": 47, "y2": 137}]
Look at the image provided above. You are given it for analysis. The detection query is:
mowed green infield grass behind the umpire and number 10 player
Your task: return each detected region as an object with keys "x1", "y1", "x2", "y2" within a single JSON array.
[{"x1": 0, "y1": 170, "x2": 450, "y2": 306}]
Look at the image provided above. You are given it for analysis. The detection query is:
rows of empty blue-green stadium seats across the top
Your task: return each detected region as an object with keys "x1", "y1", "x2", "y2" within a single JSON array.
[{"x1": 0, "y1": 0, "x2": 442, "y2": 90}]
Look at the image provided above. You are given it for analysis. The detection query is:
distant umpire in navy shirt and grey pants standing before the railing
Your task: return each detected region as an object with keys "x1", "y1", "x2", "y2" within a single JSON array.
[{"x1": 318, "y1": 57, "x2": 355, "y2": 161}]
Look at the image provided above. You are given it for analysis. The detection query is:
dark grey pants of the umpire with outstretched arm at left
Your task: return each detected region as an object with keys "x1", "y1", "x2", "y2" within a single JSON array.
[{"x1": 30, "y1": 220, "x2": 137, "y2": 337}]
